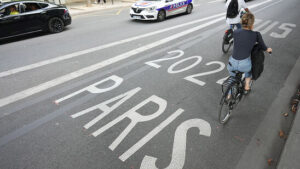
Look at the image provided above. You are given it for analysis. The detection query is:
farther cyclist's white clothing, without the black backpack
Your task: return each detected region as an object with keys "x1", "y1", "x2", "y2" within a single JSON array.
[{"x1": 226, "y1": 0, "x2": 250, "y2": 29}]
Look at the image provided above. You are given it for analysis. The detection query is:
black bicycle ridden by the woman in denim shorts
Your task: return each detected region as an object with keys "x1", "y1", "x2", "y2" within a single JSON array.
[{"x1": 218, "y1": 71, "x2": 252, "y2": 124}]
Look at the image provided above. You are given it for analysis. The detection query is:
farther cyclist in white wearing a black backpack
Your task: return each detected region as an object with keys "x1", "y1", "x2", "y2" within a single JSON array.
[{"x1": 226, "y1": 0, "x2": 250, "y2": 29}]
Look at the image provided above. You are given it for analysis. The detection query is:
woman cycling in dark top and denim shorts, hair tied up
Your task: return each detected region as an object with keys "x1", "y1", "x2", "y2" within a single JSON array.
[{"x1": 227, "y1": 13, "x2": 272, "y2": 94}]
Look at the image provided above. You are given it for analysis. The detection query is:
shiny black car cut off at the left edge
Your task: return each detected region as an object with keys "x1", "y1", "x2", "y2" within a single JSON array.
[{"x1": 0, "y1": 1, "x2": 72, "y2": 39}]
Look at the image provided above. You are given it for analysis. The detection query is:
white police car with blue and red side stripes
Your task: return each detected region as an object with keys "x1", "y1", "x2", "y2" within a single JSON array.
[{"x1": 130, "y1": 0, "x2": 193, "y2": 21}]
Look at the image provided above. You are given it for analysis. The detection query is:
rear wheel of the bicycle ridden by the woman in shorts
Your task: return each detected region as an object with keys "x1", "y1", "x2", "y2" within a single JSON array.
[{"x1": 219, "y1": 95, "x2": 232, "y2": 124}]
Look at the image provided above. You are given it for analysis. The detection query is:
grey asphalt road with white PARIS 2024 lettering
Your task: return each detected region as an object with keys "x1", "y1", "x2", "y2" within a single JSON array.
[{"x1": 0, "y1": 0, "x2": 300, "y2": 169}]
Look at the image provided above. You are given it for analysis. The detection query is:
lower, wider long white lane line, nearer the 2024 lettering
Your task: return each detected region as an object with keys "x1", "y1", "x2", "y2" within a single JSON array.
[{"x1": 0, "y1": 0, "x2": 272, "y2": 107}]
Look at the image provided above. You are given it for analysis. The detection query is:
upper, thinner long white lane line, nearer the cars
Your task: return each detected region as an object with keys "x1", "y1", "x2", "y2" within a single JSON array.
[{"x1": 0, "y1": 13, "x2": 224, "y2": 77}]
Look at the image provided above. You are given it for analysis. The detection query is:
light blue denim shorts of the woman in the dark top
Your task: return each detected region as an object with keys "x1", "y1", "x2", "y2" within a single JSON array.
[{"x1": 227, "y1": 56, "x2": 252, "y2": 78}]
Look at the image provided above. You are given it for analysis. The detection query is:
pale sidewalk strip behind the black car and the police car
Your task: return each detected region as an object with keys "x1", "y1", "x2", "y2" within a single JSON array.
[{"x1": 66, "y1": 0, "x2": 136, "y2": 16}]
